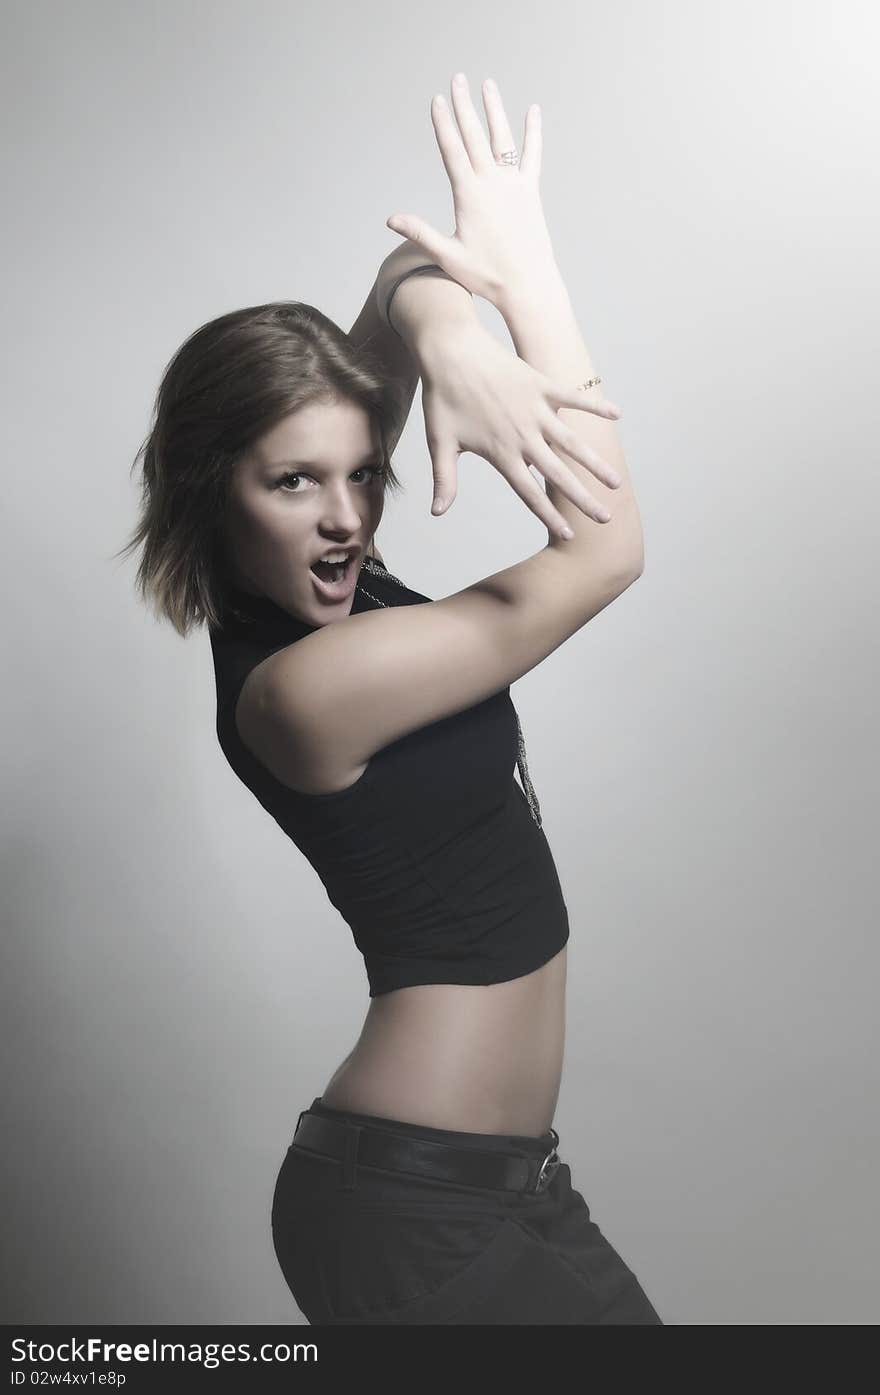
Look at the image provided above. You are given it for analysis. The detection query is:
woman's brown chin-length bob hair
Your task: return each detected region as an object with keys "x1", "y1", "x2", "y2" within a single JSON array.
[{"x1": 114, "y1": 300, "x2": 403, "y2": 638}]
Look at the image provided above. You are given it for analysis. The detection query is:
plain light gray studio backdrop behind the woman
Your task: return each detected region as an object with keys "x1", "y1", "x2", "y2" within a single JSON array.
[{"x1": 1, "y1": 0, "x2": 880, "y2": 1324}]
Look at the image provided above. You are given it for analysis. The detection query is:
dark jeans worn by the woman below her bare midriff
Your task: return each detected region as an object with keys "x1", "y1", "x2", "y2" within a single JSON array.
[{"x1": 272, "y1": 1096, "x2": 662, "y2": 1325}]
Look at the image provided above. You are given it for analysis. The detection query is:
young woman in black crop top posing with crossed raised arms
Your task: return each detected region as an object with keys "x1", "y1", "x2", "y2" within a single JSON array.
[{"x1": 122, "y1": 75, "x2": 661, "y2": 1324}]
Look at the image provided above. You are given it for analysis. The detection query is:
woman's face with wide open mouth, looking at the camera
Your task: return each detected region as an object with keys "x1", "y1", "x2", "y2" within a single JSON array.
[{"x1": 220, "y1": 400, "x2": 385, "y2": 625}]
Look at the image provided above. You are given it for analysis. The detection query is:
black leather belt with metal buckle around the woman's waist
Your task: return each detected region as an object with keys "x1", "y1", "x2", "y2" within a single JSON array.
[{"x1": 293, "y1": 1109, "x2": 561, "y2": 1191}]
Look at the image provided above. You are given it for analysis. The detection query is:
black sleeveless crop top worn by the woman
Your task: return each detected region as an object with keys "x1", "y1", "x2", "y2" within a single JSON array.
[{"x1": 209, "y1": 565, "x2": 569, "y2": 997}]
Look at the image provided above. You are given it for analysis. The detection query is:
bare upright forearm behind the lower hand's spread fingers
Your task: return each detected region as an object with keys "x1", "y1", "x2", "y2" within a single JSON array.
[{"x1": 499, "y1": 269, "x2": 644, "y2": 572}]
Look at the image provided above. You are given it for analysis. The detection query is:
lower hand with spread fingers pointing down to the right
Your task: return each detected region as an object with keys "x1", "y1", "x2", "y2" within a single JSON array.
[{"x1": 418, "y1": 319, "x2": 621, "y2": 537}]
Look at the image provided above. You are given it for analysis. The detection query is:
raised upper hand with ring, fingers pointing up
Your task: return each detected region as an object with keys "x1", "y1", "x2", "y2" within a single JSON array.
[{"x1": 388, "y1": 73, "x2": 558, "y2": 314}]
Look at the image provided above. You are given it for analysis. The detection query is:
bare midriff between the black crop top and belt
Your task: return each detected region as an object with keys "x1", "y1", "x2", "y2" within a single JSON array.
[{"x1": 321, "y1": 946, "x2": 568, "y2": 1137}]
